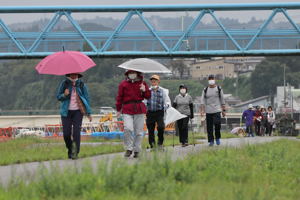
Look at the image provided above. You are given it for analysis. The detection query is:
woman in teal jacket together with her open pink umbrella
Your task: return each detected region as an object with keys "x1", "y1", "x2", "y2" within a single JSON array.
[{"x1": 36, "y1": 51, "x2": 96, "y2": 159}]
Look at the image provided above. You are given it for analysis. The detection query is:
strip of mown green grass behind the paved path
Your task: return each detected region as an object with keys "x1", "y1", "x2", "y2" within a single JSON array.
[{"x1": 0, "y1": 135, "x2": 202, "y2": 165}]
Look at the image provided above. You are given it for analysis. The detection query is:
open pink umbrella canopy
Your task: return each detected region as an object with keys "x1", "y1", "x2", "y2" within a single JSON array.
[{"x1": 35, "y1": 51, "x2": 96, "y2": 75}]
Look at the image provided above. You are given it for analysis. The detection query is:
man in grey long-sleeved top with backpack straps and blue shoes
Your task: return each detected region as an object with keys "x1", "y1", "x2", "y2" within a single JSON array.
[{"x1": 200, "y1": 75, "x2": 226, "y2": 146}]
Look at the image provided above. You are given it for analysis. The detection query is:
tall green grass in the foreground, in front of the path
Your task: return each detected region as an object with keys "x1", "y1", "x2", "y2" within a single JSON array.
[{"x1": 0, "y1": 140, "x2": 300, "y2": 200}]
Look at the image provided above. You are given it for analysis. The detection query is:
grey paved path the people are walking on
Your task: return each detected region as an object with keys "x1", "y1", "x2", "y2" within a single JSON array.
[{"x1": 0, "y1": 137, "x2": 300, "y2": 186}]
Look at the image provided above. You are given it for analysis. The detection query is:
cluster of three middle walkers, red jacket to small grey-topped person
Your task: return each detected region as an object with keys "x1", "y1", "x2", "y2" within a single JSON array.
[{"x1": 116, "y1": 70, "x2": 193, "y2": 158}]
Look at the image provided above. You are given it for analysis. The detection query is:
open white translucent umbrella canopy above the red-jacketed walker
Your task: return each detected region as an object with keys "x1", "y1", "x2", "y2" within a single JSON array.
[{"x1": 118, "y1": 58, "x2": 172, "y2": 73}]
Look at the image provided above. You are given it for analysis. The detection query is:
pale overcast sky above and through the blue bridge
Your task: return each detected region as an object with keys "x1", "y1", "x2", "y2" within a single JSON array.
[{"x1": 0, "y1": 0, "x2": 300, "y2": 24}]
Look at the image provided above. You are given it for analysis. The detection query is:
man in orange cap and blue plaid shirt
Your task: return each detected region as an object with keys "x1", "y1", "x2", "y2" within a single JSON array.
[{"x1": 146, "y1": 75, "x2": 171, "y2": 148}]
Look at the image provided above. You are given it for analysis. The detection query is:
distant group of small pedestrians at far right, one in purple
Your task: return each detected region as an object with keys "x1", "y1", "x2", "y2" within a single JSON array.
[{"x1": 242, "y1": 104, "x2": 275, "y2": 137}]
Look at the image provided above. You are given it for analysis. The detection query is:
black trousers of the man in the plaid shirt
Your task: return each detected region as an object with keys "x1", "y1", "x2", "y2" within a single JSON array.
[{"x1": 146, "y1": 110, "x2": 165, "y2": 148}]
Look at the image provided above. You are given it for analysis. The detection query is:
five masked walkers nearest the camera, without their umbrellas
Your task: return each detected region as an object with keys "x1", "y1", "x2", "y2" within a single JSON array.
[{"x1": 57, "y1": 70, "x2": 226, "y2": 159}]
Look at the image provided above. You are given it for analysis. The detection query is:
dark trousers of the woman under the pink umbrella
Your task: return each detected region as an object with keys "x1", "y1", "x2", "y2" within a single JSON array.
[{"x1": 61, "y1": 110, "x2": 83, "y2": 155}]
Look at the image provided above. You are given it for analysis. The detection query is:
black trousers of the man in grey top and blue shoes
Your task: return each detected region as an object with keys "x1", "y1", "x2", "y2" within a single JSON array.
[{"x1": 206, "y1": 112, "x2": 221, "y2": 142}]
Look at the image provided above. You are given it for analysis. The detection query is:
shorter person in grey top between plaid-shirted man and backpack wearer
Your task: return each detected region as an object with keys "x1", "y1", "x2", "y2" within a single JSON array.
[{"x1": 173, "y1": 84, "x2": 194, "y2": 147}]
